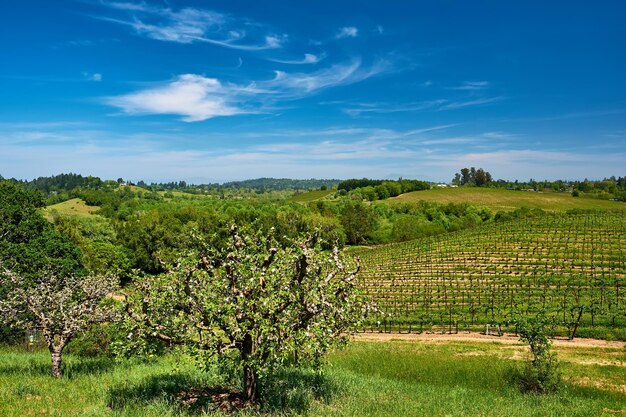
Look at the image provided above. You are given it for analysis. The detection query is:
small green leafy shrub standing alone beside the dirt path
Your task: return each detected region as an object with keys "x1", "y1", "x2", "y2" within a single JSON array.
[{"x1": 515, "y1": 314, "x2": 562, "y2": 394}]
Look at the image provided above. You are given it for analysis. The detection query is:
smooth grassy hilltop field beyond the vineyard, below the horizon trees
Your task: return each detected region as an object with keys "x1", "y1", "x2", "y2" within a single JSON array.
[{"x1": 385, "y1": 187, "x2": 626, "y2": 212}]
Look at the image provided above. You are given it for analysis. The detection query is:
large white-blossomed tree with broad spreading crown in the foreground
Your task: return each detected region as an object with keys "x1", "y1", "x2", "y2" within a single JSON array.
[{"x1": 127, "y1": 226, "x2": 373, "y2": 403}]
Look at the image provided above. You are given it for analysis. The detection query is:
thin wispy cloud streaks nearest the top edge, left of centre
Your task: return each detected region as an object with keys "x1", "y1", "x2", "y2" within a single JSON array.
[{"x1": 98, "y1": 2, "x2": 287, "y2": 51}]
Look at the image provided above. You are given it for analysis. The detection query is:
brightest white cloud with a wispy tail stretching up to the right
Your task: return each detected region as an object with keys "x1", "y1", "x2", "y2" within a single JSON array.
[{"x1": 104, "y1": 60, "x2": 388, "y2": 122}]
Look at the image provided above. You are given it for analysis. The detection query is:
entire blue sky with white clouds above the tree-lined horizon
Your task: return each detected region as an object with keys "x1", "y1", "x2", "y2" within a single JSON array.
[{"x1": 0, "y1": 0, "x2": 626, "y2": 183}]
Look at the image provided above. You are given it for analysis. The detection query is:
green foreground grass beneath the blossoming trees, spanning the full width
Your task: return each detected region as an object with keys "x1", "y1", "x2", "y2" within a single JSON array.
[{"x1": 0, "y1": 341, "x2": 626, "y2": 417}]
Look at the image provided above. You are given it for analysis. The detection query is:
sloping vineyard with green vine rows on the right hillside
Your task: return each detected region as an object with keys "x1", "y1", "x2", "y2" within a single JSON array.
[{"x1": 353, "y1": 212, "x2": 626, "y2": 339}]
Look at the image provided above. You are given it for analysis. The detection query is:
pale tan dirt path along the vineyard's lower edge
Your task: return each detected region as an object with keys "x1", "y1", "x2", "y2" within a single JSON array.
[{"x1": 354, "y1": 332, "x2": 626, "y2": 349}]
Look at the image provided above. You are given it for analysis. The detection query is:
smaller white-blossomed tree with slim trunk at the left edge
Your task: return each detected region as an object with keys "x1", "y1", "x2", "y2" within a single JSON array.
[{"x1": 0, "y1": 270, "x2": 117, "y2": 378}]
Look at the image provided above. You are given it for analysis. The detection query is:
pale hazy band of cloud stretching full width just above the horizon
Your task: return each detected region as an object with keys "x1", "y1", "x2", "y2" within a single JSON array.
[{"x1": 0, "y1": 122, "x2": 626, "y2": 182}]
